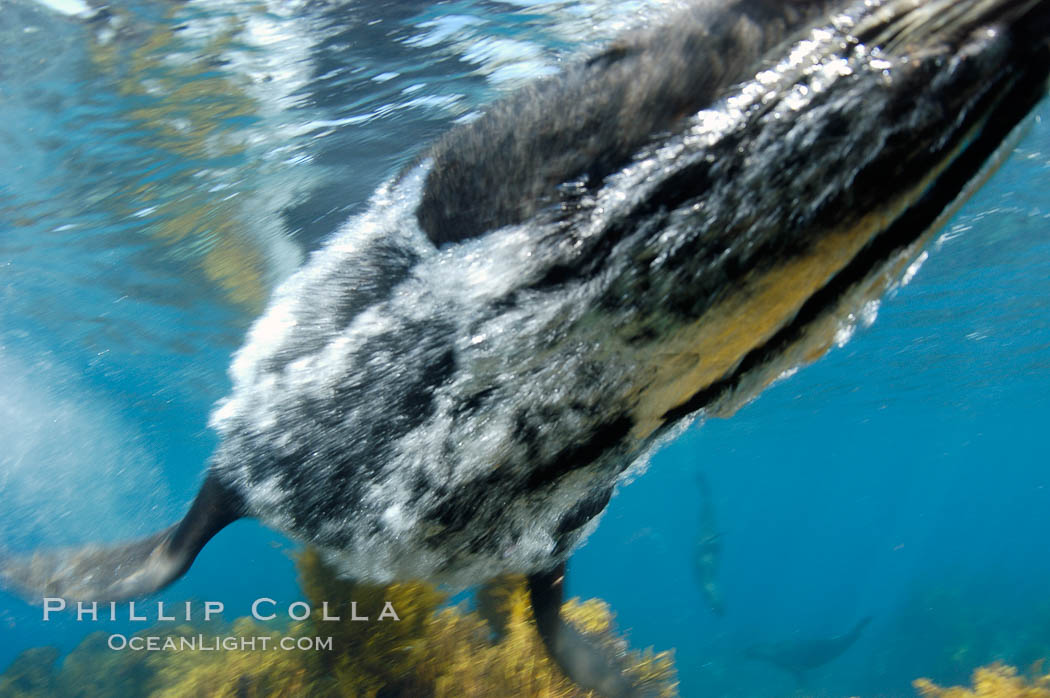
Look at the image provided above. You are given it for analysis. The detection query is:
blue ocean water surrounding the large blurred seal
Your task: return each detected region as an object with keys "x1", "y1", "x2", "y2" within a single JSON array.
[{"x1": 0, "y1": 0, "x2": 1050, "y2": 696}]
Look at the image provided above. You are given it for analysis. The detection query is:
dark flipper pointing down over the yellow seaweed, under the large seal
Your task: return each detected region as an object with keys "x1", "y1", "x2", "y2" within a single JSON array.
[{"x1": 528, "y1": 563, "x2": 642, "y2": 698}]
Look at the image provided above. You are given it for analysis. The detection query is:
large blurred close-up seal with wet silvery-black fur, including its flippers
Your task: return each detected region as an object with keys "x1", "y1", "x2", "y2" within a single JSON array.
[{"x1": 0, "y1": 0, "x2": 1050, "y2": 696}]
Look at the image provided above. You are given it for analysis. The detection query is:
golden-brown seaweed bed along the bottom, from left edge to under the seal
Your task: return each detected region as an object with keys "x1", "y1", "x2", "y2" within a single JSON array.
[{"x1": 0, "y1": 549, "x2": 677, "y2": 698}]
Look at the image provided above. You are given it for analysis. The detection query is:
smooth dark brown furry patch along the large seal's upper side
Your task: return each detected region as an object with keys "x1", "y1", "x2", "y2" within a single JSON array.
[{"x1": 417, "y1": 0, "x2": 825, "y2": 246}]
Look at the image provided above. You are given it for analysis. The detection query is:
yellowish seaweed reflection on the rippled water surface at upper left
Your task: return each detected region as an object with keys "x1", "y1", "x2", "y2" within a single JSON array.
[{"x1": 88, "y1": 4, "x2": 298, "y2": 314}]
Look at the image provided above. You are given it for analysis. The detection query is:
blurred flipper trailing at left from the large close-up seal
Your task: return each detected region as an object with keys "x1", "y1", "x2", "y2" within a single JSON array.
[{"x1": 0, "y1": 473, "x2": 243, "y2": 602}]
